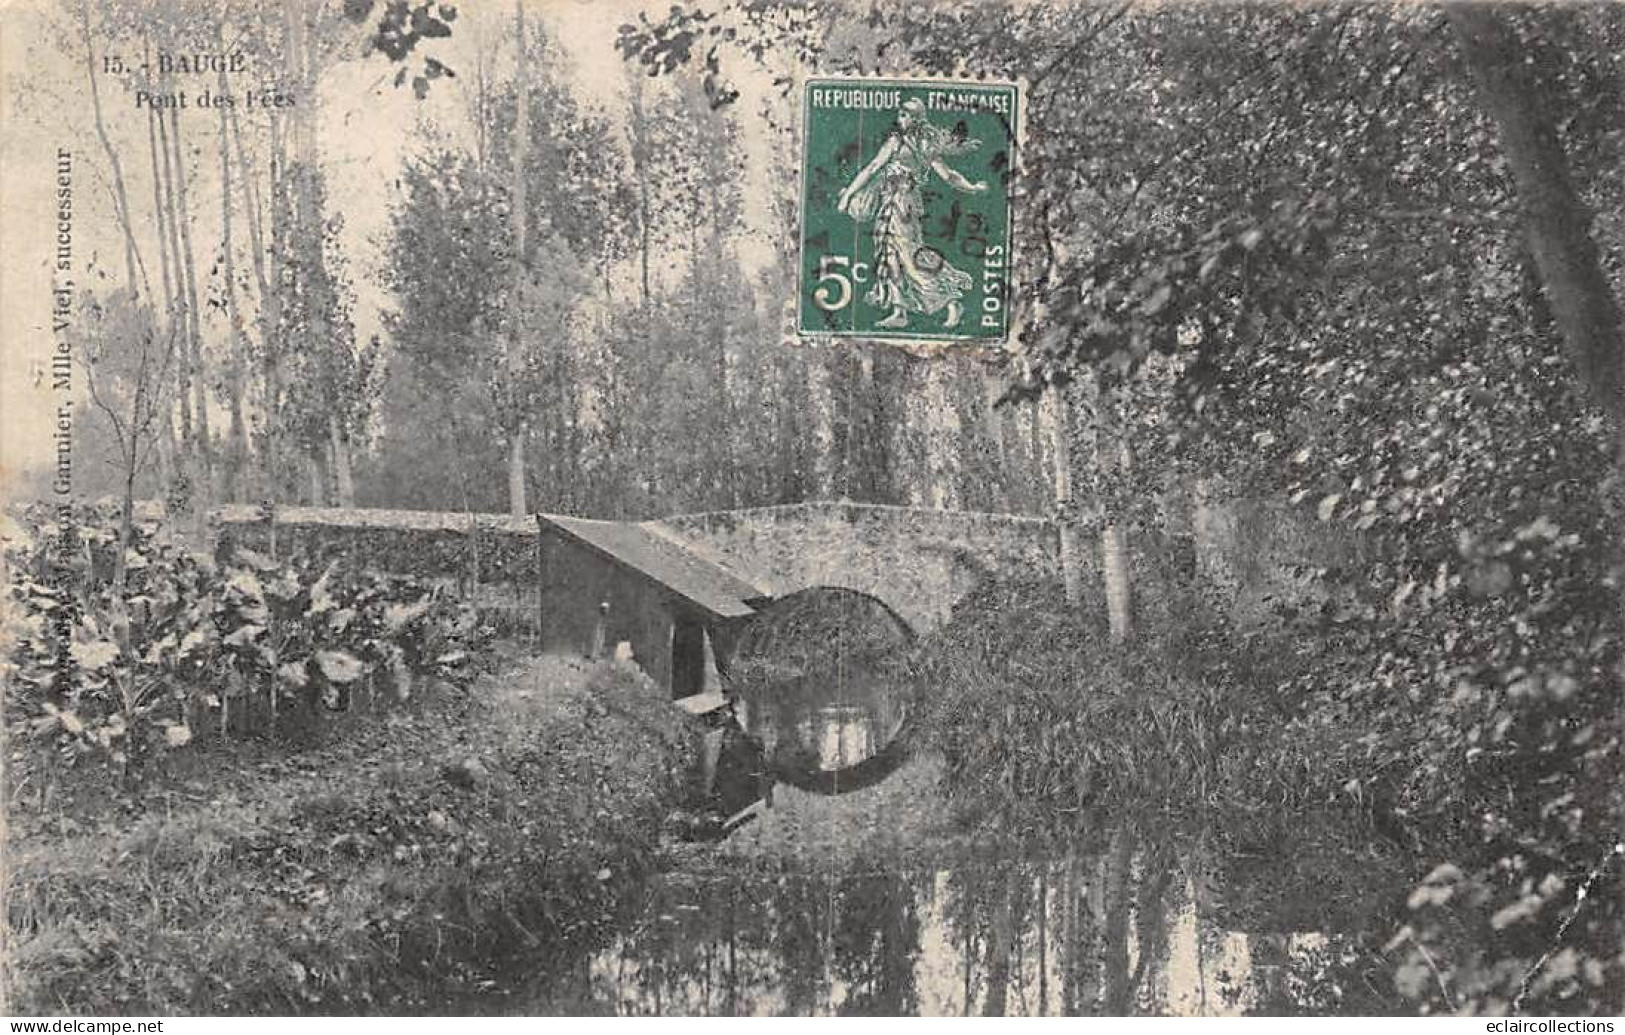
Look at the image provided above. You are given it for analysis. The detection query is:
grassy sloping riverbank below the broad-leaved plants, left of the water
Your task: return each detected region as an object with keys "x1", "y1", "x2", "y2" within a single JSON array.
[{"x1": 5, "y1": 658, "x2": 696, "y2": 1014}]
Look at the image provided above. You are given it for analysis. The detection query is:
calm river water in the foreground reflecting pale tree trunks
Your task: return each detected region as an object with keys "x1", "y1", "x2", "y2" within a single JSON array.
[{"x1": 527, "y1": 759, "x2": 1406, "y2": 1016}]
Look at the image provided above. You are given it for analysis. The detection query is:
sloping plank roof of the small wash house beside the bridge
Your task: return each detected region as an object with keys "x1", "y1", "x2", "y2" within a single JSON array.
[{"x1": 536, "y1": 513, "x2": 762, "y2": 617}]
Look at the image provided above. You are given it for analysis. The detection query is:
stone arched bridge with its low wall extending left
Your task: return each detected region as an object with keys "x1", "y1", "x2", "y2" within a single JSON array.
[{"x1": 213, "y1": 500, "x2": 1058, "y2": 634}]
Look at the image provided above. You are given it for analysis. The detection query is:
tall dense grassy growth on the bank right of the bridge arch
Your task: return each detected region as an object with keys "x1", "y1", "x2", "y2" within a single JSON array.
[{"x1": 913, "y1": 568, "x2": 1326, "y2": 825}]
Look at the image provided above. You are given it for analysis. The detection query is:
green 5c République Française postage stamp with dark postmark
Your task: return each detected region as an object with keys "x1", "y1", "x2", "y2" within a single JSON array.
[{"x1": 800, "y1": 78, "x2": 1019, "y2": 343}]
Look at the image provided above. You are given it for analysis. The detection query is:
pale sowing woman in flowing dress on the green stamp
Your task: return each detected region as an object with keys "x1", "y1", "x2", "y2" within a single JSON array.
[{"x1": 835, "y1": 97, "x2": 988, "y2": 328}]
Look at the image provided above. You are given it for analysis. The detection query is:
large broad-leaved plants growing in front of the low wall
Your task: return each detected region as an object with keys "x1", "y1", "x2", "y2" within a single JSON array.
[{"x1": 7, "y1": 509, "x2": 486, "y2": 770}]
